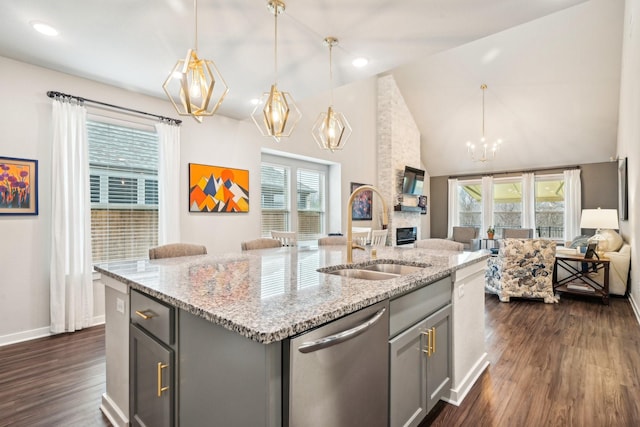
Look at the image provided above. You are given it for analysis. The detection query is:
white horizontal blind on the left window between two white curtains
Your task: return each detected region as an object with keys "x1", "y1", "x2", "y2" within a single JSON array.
[{"x1": 87, "y1": 120, "x2": 158, "y2": 262}]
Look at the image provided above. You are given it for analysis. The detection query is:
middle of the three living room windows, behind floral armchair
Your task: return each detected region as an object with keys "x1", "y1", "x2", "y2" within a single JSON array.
[{"x1": 493, "y1": 178, "x2": 522, "y2": 238}]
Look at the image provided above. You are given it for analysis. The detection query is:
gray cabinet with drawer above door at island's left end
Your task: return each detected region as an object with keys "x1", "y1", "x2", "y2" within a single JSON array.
[{"x1": 129, "y1": 291, "x2": 176, "y2": 427}]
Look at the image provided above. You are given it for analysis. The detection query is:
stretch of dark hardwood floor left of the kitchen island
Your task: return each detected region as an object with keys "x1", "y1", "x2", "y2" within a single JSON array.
[{"x1": 0, "y1": 326, "x2": 111, "y2": 427}]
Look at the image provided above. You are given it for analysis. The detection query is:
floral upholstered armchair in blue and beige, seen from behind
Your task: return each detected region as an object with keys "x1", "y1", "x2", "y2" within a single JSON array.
[{"x1": 485, "y1": 239, "x2": 558, "y2": 303}]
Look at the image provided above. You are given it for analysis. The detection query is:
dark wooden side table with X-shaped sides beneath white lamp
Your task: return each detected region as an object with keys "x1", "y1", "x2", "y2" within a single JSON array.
[{"x1": 553, "y1": 254, "x2": 611, "y2": 305}]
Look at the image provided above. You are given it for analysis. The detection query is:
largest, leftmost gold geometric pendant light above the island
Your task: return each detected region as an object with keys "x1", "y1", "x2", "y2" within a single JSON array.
[{"x1": 162, "y1": 0, "x2": 229, "y2": 123}]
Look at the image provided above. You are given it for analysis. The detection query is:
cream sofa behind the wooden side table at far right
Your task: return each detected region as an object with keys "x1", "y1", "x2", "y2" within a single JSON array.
[{"x1": 556, "y1": 230, "x2": 631, "y2": 295}]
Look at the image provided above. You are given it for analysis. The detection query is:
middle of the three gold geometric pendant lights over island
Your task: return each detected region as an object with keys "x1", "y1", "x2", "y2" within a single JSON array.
[{"x1": 251, "y1": 0, "x2": 302, "y2": 142}]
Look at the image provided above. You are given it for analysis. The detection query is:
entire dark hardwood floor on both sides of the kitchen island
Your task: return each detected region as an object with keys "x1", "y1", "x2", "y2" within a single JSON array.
[{"x1": 0, "y1": 295, "x2": 640, "y2": 427}]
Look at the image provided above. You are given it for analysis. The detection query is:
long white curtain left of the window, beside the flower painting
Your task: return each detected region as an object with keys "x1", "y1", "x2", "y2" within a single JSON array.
[{"x1": 50, "y1": 99, "x2": 93, "y2": 333}]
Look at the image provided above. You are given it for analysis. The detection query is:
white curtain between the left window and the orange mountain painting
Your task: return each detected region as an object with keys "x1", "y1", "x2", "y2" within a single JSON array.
[{"x1": 156, "y1": 123, "x2": 184, "y2": 245}]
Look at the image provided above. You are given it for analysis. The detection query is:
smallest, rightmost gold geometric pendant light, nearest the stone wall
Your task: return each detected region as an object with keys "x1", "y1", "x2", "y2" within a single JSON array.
[{"x1": 311, "y1": 37, "x2": 351, "y2": 152}]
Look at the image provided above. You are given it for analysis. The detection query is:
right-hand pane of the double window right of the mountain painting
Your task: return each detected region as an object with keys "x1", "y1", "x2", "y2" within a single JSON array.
[{"x1": 296, "y1": 169, "x2": 325, "y2": 240}]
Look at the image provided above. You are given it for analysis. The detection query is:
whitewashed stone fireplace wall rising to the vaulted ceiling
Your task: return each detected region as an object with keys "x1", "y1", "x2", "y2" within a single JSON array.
[{"x1": 377, "y1": 75, "x2": 421, "y2": 246}]
